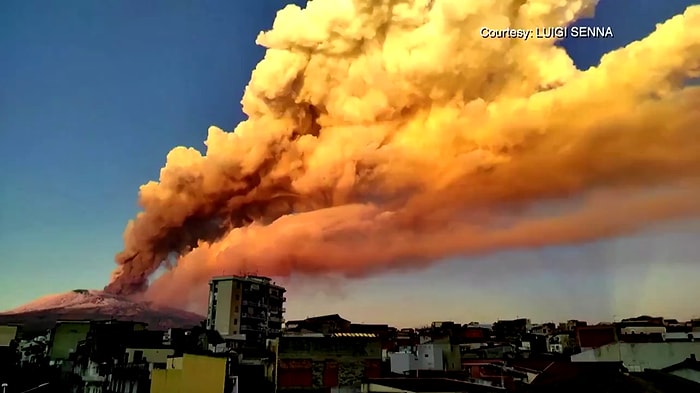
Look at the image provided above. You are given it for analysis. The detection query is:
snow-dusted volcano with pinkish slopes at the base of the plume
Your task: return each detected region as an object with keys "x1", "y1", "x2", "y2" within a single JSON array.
[{"x1": 0, "y1": 289, "x2": 204, "y2": 333}]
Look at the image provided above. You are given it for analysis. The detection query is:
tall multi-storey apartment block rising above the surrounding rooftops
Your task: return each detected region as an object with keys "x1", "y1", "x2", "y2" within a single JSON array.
[{"x1": 207, "y1": 275, "x2": 286, "y2": 345}]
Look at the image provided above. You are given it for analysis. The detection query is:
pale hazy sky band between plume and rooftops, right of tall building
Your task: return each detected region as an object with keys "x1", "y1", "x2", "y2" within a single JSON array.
[{"x1": 2, "y1": 222, "x2": 700, "y2": 327}]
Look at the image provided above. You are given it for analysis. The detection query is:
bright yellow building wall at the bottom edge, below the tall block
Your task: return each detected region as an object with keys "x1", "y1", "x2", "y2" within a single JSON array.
[{"x1": 151, "y1": 354, "x2": 226, "y2": 393}]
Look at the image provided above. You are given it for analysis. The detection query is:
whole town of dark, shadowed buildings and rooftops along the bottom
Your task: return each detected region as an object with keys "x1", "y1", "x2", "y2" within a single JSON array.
[{"x1": 0, "y1": 275, "x2": 700, "y2": 393}]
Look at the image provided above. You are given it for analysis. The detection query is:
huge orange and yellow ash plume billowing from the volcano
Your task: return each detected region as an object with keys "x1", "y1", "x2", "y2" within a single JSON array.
[{"x1": 107, "y1": 0, "x2": 700, "y2": 302}]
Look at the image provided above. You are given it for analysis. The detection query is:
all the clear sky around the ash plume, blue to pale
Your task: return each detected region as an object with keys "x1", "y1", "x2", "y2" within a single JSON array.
[{"x1": 0, "y1": 0, "x2": 700, "y2": 324}]
